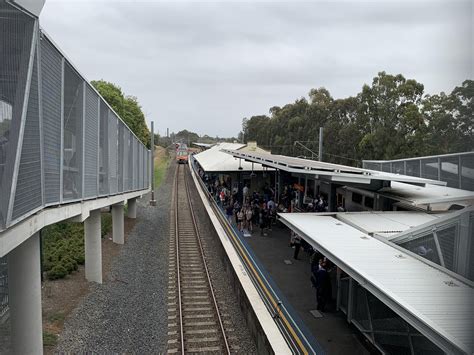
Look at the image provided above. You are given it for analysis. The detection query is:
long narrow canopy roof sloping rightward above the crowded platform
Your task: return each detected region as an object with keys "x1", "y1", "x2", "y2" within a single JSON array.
[{"x1": 223, "y1": 148, "x2": 446, "y2": 186}]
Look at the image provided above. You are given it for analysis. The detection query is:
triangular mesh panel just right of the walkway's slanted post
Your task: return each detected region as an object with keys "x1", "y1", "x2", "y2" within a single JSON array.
[{"x1": 12, "y1": 47, "x2": 43, "y2": 219}]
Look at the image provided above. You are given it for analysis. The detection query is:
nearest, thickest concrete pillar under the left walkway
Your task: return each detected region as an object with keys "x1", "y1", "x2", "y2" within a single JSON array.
[{"x1": 8, "y1": 233, "x2": 43, "y2": 354}]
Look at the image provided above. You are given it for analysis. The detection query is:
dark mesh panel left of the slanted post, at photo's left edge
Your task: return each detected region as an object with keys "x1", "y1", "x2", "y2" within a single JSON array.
[{"x1": 0, "y1": 1, "x2": 35, "y2": 229}]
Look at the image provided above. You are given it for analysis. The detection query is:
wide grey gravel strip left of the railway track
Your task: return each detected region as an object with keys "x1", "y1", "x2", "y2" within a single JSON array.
[{"x1": 56, "y1": 168, "x2": 174, "y2": 353}]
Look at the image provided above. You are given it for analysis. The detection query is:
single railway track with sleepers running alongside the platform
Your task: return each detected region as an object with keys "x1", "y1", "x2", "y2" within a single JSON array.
[{"x1": 168, "y1": 164, "x2": 232, "y2": 354}]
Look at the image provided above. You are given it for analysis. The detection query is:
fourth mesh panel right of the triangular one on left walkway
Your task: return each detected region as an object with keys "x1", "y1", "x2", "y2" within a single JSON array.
[{"x1": 99, "y1": 99, "x2": 109, "y2": 195}]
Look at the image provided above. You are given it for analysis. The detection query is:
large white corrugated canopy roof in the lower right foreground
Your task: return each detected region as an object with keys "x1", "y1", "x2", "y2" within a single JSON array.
[{"x1": 279, "y1": 213, "x2": 474, "y2": 354}]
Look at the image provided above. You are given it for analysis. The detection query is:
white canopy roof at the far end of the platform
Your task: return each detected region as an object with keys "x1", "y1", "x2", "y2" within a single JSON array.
[{"x1": 194, "y1": 143, "x2": 273, "y2": 172}]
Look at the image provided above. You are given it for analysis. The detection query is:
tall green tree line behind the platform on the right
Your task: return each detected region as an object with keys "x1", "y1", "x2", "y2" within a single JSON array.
[{"x1": 239, "y1": 72, "x2": 474, "y2": 166}]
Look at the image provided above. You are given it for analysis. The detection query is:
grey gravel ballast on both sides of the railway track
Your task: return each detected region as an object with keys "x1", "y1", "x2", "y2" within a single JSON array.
[{"x1": 55, "y1": 164, "x2": 256, "y2": 354}]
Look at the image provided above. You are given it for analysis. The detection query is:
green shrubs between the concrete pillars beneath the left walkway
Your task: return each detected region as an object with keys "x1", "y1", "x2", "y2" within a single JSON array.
[{"x1": 42, "y1": 213, "x2": 112, "y2": 280}]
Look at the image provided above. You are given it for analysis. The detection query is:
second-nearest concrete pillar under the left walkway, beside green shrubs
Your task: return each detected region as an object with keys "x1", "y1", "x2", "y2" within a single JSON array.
[{"x1": 84, "y1": 210, "x2": 102, "y2": 284}]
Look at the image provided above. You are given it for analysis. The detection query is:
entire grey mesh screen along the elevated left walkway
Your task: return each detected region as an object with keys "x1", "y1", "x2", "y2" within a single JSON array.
[{"x1": 0, "y1": 0, "x2": 151, "y2": 232}]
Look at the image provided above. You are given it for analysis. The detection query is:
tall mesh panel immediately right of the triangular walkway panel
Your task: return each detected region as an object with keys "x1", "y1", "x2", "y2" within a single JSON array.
[{"x1": 41, "y1": 38, "x2": 62, "y2": 204}]
